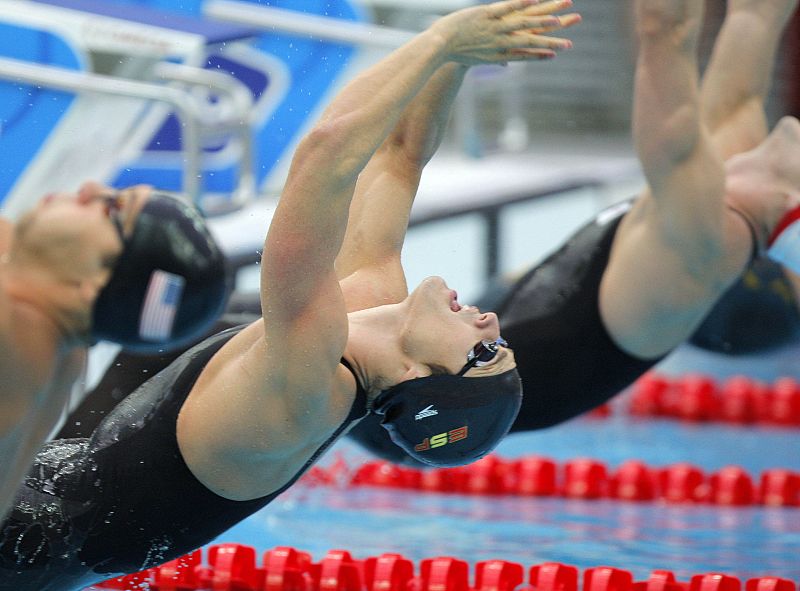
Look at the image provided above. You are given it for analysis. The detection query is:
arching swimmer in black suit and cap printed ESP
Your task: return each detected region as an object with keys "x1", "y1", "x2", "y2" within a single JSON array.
[{"x1": 0, "y1": 0, "x2": 579, "y2": 591}]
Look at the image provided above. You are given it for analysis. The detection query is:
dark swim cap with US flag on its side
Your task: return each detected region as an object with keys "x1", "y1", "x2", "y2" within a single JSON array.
[{"x1": 91, "y1": 193, "x2": 230, "y2": 353}]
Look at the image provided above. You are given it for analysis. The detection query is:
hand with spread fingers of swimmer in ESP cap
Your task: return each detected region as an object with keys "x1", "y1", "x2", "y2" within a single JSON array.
[{"x1": 433, "y1": 0, "x2": 581, "y2": 65}]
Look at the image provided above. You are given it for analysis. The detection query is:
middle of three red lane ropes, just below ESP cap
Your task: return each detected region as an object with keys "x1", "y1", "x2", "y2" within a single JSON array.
[{"x1": 342, "y1": 455, "x2": 800, "y2": 507}]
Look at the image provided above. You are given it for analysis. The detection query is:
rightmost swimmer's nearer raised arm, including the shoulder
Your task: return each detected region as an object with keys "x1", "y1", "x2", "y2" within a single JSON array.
[{"x1": 600, "y1": 0, "x2": 752, "y2": 359}]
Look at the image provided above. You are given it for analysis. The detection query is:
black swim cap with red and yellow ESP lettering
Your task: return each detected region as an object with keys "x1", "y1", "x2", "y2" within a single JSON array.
[{"x1": 372, "y1": 368, "x2": 522, "y2": 467}]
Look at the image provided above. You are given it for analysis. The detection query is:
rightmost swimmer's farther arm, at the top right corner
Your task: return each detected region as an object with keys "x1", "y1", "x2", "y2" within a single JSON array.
[{"x1": 701, "y1": 0, "x2": 798, "y2": 160}]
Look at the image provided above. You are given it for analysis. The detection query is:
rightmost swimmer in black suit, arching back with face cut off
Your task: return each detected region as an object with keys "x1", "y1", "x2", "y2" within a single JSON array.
[{"x1": 350, "y1": 0, "x2": 800, "y2": 464}]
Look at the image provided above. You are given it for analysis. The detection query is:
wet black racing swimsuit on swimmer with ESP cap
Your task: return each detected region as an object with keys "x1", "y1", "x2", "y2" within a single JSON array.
[{"x1": 0, "y1": 326, "x2": 366, "y2": 591}]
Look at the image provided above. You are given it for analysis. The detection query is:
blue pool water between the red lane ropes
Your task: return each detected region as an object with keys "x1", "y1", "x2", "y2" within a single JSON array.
[{"x1": 212, "y1": 416, "x2": 800, "y2": 581}]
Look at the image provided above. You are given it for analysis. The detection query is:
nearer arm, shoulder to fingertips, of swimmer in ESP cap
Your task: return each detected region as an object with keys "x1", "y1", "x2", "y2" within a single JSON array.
[{"x1": 172, "y1": 0, "x2": 580, "y2": 498}]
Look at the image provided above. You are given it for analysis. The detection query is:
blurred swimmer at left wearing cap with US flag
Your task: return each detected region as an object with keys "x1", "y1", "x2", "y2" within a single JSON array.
[{"x1": 0, "y1": 183, "x2": 227, "y2": 515}]
